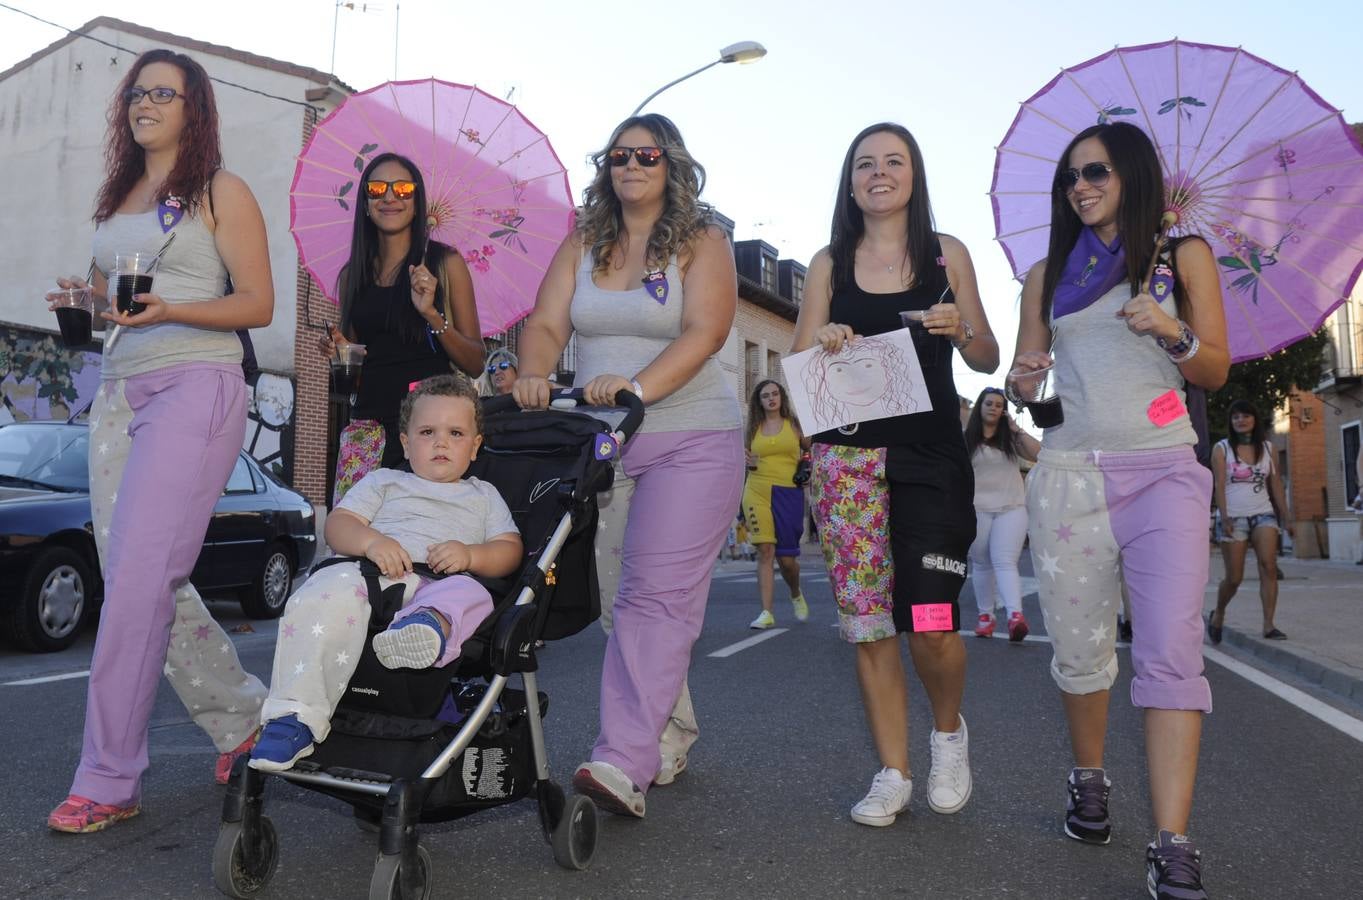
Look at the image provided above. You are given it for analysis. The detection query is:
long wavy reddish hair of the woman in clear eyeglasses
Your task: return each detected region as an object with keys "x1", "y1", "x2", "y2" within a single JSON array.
[{"x1": 94, "y1": 49, "x2": 222, "y2": 222}]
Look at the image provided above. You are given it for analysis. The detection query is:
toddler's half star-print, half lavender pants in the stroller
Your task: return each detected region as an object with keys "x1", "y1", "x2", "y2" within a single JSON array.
[{"x1": 260, "y1": 562, "x2": 493, "y2": 742}]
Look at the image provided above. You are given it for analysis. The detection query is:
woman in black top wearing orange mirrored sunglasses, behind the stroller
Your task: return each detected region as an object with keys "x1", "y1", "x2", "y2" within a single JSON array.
[{"x1": 320, "y1": 153, "x2": 483, "y2": 505}]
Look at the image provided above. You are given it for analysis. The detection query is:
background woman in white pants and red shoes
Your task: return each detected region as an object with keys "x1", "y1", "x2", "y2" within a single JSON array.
[{"x1": 965, "y1": 387, "x2": 1041, "y2": 644}]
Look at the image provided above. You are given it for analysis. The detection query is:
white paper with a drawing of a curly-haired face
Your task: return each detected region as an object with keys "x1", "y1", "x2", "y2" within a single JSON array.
[{"x1": 781, "y1": 329, "x2": 932, "y2": 435}]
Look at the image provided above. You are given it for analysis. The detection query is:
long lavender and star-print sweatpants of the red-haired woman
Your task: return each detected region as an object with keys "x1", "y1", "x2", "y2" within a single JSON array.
[{"x1": 71, "y1": 363, "x2": 266, "y2": 806}]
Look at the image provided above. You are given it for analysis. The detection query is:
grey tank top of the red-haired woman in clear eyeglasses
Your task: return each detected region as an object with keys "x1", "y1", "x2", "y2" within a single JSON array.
[{"x1": 94, "y1": 210, "x2": 241, "y2": 380}]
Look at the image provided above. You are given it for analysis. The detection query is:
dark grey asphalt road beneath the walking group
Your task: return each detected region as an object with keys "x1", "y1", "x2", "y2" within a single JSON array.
[{"x1": 0, "y1": 551, "x2": 1363, "y2": 900}]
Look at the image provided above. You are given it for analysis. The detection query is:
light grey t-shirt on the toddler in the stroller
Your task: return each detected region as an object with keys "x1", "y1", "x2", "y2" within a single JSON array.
[{"x1": 337, "y1": 469, "x2": 519, "y2": 562}]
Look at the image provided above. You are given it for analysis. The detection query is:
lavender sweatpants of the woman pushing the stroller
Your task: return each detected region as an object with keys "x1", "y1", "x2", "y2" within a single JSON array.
[{"x1": 592, "y1": 430, "x2": 744, "y2": 791}]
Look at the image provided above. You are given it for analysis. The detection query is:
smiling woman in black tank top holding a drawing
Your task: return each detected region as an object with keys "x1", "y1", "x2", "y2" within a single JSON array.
[{"x1": 792, "y1": 123, "x2": 999, "y2": 825}]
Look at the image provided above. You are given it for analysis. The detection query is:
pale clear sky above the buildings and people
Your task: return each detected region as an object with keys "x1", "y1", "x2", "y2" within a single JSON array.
[{"x1": 0, "y1": 0, "x2": 1363, "y2": 398}]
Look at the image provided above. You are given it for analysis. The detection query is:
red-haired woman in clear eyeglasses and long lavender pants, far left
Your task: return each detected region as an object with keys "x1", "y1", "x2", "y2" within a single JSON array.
[{"x1": 48, "y1": 49, "x2": 274, "y2": 833}]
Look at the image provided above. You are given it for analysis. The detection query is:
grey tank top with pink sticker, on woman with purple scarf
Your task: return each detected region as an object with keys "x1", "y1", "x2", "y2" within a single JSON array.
[{"x1": 1043, "y1": 282, "x2": 1197, "y2": 451}]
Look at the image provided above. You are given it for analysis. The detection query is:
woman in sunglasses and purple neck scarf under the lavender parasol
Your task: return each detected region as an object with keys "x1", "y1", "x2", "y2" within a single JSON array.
[{"x1": 1013, "y1": 123, "x2": 1229, "y2": 900}]
